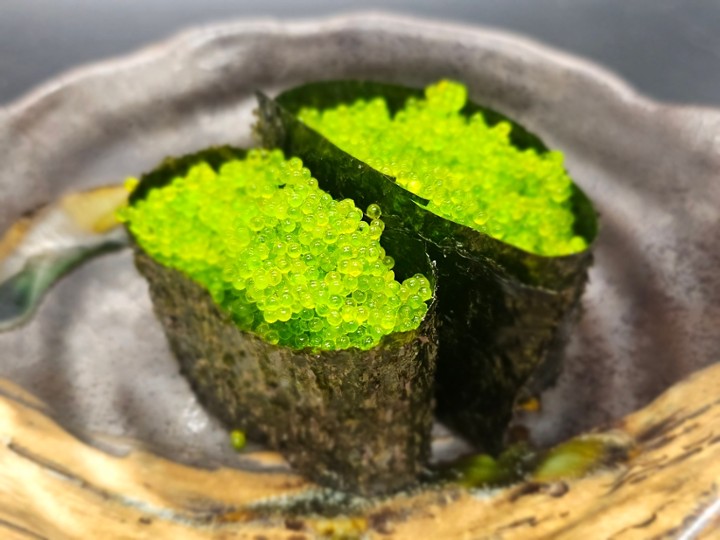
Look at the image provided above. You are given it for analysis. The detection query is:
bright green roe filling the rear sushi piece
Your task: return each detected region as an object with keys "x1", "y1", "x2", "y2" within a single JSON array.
[{"x1": 298, "y1": 81, "x2": 587, "y2": 256}]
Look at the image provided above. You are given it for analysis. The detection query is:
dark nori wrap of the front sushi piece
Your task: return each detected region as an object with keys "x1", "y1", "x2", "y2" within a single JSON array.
[{"x1": 131, "y1": 148, "x2": 436, "y2": 494}]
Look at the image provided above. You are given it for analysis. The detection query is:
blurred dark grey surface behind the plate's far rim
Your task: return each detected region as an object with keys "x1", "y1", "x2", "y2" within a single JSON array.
[{"x1": 0, "y1": 0, "x2": 720, "y2": 106}]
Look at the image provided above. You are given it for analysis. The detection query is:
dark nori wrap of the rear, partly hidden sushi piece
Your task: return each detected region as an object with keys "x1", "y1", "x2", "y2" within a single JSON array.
[{"x1": 257, "y1": 81, "x2": 597, "y2": 453}]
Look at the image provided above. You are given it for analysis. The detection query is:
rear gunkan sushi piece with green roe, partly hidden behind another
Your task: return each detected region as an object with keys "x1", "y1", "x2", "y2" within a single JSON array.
[{"x1": 258, "y1": 81, "x2": 597, "y2": 452}]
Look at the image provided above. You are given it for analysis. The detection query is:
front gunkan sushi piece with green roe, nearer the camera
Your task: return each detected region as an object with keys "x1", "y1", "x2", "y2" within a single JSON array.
[{"x1": 121, "y1": 147, "x2": 436, "y2": 494}]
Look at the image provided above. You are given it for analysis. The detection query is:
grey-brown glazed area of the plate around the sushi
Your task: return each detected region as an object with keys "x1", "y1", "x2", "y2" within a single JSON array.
[{"x1": 0, "y1": 15, "x2": 720, "y2": 463}]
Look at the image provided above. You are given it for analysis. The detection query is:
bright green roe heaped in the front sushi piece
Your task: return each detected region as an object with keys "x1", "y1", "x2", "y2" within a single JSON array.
[{"x1": 120, "y1": 150, "x2": 432, "y2": 350}]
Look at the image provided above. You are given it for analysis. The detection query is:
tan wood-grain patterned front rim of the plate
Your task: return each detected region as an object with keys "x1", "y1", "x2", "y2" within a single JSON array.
[{"x1": 0, "y1": 365, "x2": 720, "y2": 540}]
